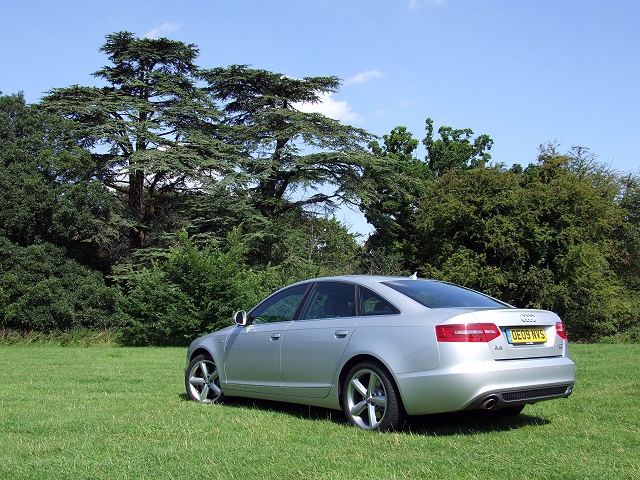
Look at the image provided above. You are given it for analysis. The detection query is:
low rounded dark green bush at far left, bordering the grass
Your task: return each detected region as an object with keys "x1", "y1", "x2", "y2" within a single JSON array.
[{"x1": 0, "y1": 237, "x2": 121, "y2": 332}]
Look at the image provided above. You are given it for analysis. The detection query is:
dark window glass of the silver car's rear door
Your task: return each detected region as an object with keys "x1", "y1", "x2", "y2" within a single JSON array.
[{"x1": 302, "y1": 282, "x2": 356, "y2": 320}]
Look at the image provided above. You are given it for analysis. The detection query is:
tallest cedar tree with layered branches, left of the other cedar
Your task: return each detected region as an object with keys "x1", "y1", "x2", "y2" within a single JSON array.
[{"x1": 42, "y1": 32, "x2": 233, "y2": 247}]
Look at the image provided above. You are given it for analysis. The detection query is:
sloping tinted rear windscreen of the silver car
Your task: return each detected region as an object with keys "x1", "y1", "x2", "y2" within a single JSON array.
[{"x1": 382, "y1": 280, "x2": 509, "y2": 308}]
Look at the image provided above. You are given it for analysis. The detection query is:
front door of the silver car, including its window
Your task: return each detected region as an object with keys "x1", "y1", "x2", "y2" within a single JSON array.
[{"x1": 223, "y1": 284, "x2": 309, "y2": 394}]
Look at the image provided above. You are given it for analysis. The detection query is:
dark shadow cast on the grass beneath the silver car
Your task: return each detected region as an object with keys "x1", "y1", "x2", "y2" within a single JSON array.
[{"x1": 180, "y1": 393, "x2": 551, "y2": 437}]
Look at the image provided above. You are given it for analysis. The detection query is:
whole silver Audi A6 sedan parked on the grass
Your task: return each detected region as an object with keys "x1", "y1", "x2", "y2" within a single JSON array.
[{"x1": 185, "y1": 275, "x2": 575, "y2": 430}]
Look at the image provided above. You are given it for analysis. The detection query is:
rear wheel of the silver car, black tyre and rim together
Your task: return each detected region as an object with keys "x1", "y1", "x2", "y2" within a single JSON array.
[{"x1": 342, "y1": 362, "x2": 406, "y2": 431}]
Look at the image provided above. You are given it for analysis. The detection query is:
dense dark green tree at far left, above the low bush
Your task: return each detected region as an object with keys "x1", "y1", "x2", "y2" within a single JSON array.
[{"x1": 0, "y1": 90, "x2": 124, "y2": 270}]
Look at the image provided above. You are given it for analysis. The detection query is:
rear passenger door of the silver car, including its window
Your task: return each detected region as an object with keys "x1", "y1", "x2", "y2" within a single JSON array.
[{"x1": 281, "y1": 282, "x2": 359, "y2": 398}]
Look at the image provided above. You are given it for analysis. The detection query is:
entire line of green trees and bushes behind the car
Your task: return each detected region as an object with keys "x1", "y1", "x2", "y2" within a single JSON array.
[{"x1": 0, "y1": 32, "x2": 640, "y2": 345}]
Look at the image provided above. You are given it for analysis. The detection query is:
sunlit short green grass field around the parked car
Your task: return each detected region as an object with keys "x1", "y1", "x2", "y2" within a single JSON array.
[{"x1": 0, "y1": 345, "x2": 640, "y2": 480}]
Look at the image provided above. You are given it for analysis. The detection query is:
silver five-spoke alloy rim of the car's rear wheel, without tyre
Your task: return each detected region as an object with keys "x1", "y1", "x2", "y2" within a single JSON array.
[{"x1": 347, "y1": 368, "x2": 387, "y2": 430}]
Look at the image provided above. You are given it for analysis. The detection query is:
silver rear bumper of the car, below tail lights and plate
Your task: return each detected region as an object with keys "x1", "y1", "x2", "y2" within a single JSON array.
[{"x1": 396, "y1": 357, "x2": 575, "y2": 415}]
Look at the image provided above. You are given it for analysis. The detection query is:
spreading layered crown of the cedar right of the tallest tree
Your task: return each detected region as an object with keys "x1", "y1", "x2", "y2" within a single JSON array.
[{"x1": 202, "y1": 65, "x2": 371, "y2": 218}]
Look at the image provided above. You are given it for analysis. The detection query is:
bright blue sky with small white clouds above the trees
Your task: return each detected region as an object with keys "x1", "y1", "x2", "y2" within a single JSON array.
[{"x1": 0, "y1": 0, "x2": 640, "y2": 231}]
